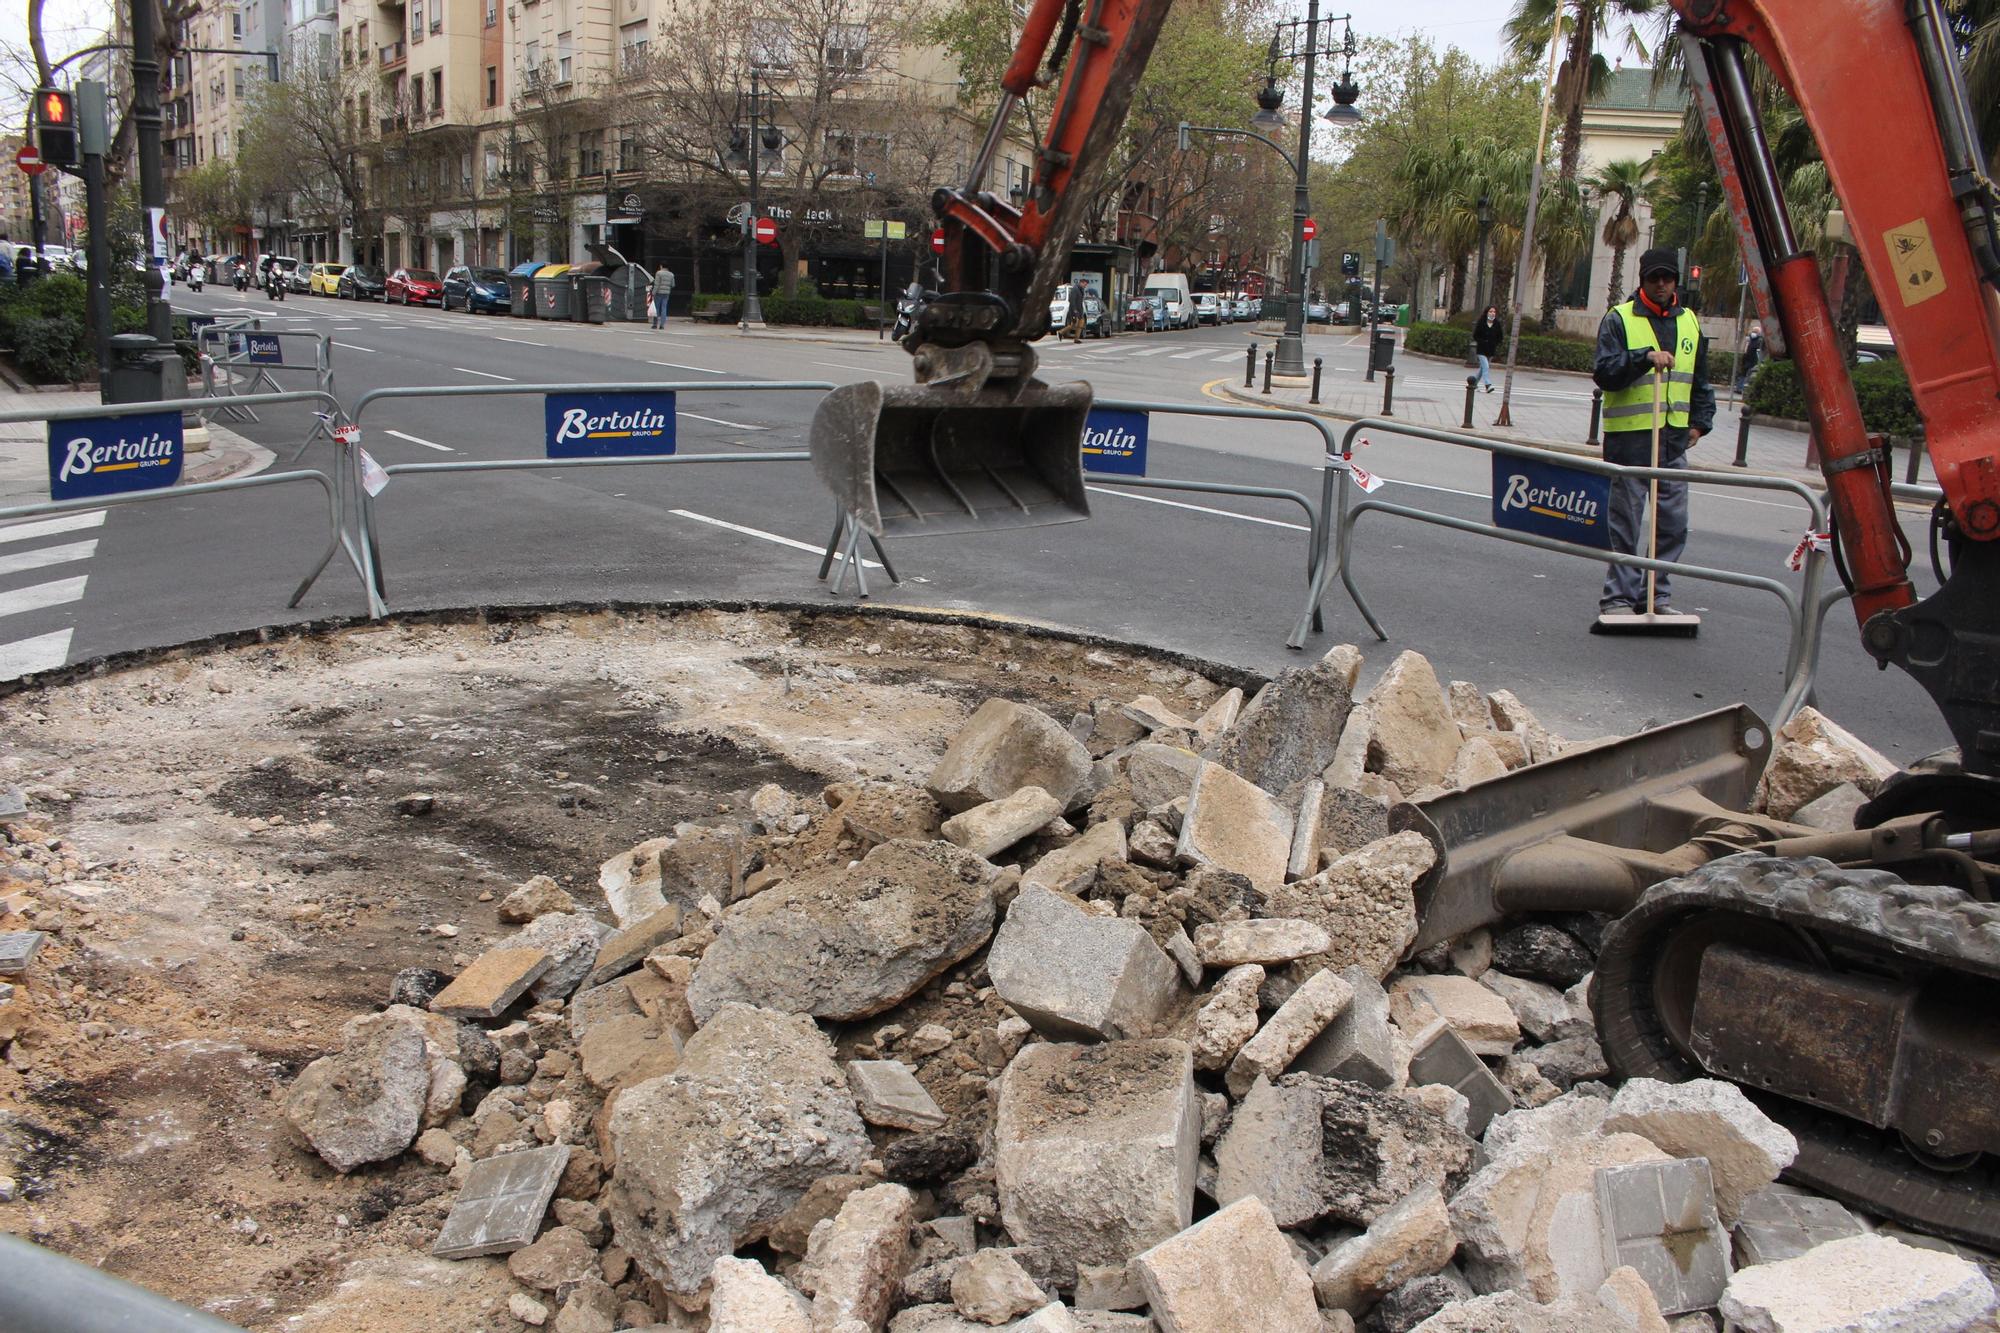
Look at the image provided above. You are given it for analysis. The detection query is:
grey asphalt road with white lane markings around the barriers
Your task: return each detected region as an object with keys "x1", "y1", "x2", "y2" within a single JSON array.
[{"x1": 0, "y1": 288, "x2": 1948, "y2": 761}]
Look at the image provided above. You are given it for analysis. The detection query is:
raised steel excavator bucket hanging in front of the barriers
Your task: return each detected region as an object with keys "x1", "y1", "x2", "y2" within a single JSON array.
[{"x1": 812, "y1": 382, "x2": 1090, "y2": 536}]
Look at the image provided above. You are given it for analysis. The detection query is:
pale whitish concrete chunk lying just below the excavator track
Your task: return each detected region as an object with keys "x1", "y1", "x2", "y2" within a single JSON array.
[{"x1": 1604, "y1": 1079, "x2": 1798, "y2": 1223}]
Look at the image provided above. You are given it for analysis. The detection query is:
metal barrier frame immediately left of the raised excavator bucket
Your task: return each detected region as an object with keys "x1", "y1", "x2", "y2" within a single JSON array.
[{"x1": 340, "y1": 380, "x2": 834, "y2": 618}]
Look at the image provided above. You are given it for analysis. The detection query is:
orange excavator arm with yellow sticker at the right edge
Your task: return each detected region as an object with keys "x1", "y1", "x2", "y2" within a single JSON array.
[{"x1": 1672, "y1": 0, "x2": 2000, "y2": 773}]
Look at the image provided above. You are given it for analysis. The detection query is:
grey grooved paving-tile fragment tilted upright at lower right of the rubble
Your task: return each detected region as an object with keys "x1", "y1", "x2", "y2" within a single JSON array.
[{"x1": 1598, "y1": 1157, "x2": 1730, "y2": 1315}]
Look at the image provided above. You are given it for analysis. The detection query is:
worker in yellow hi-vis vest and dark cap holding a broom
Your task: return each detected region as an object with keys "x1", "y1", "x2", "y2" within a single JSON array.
[{"x1": 1590, "y1": 248, "x2": 1716, "y2": 614}]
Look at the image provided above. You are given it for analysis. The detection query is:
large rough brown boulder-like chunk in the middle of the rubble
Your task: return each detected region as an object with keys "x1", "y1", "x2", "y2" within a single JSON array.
[{"x1": 688, "y1": 839, "x2": 1000, "y2": 1023}]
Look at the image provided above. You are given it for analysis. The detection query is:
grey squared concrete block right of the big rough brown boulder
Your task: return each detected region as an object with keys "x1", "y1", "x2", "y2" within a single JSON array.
[{"x1": 986, "y1": 889, "x2": 1180, "y2": 1039}]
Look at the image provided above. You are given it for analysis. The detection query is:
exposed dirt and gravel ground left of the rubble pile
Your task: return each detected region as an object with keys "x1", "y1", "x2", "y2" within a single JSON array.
[{"x1": 0, "y1": 610, "x2": 1244, "y2": 1333}]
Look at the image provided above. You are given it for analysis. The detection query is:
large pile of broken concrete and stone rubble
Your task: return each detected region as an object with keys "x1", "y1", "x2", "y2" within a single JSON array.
[{"x1": 262, "y1": 648, "x2": 1994, "y2": 1333}]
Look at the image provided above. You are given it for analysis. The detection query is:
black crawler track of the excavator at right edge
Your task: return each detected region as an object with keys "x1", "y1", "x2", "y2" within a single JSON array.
[{"x1": 1592, "y1": 855, "x2": 2000, "y2": 1249}]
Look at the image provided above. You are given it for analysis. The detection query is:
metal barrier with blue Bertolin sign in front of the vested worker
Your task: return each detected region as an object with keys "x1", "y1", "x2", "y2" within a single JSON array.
[{"x1": 1320, "y1": 418, "x2": 1828, "y2": 727}]
